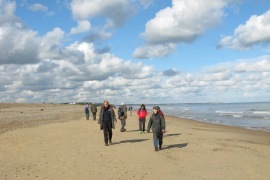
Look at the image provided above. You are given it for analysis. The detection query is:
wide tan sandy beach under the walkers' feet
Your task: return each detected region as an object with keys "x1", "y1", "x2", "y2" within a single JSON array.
[{"x1": 0, "y1": 103, "x2": 270, "y2": 180}]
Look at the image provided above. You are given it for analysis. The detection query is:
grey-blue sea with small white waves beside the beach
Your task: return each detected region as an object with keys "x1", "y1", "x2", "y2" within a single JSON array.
[{"x1": 132, "y1": 102, "x2": 270, "y2": 132}]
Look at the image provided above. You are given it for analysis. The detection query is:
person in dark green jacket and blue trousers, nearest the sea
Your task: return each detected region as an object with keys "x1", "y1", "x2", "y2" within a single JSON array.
[{"x1": 147, "y1": 106, "x2": 165, "y2": 151}]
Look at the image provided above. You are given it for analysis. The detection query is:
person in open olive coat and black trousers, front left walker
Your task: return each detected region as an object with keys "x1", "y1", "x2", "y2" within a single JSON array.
[{"x1": 98, "y1": 100, "x2": 117, "y2": 146}]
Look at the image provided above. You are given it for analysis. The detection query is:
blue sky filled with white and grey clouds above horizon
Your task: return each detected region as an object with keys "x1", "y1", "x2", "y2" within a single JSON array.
[{"x1": 0, "y1": 0, "x2": 270, "y2": 104}]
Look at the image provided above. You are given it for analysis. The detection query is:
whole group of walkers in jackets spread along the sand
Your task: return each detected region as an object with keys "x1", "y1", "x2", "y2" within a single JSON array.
[{"x1": 85, "y1": 100, "x2": 166, "y2": 151}]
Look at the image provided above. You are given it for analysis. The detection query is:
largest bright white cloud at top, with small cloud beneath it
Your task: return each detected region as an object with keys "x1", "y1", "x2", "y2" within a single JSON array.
[{"x1": 134, "y1": 0, "x2": 227, "y2": 58}]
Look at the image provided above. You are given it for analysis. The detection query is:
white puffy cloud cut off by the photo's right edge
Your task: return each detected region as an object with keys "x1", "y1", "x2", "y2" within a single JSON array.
[{"x1": 219, "y1": 10, "x2": 270, "y2": 49}]
